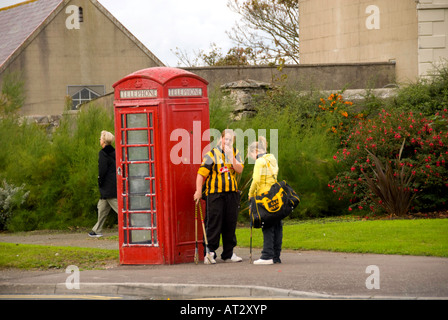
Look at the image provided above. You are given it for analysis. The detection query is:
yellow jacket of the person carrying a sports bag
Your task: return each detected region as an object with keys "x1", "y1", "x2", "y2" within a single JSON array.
[{"x1": 249, "y1": 154, "x2": 278, "y2": 197}]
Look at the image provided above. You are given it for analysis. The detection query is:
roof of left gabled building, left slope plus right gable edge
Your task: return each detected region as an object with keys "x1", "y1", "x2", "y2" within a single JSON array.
[{"x1": 0, "y1": 0, "x2": 164, "y2": 72}]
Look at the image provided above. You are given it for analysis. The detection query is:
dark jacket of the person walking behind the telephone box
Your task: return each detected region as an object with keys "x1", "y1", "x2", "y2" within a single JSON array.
[{"x1": 98, "y1": 145, "x2": 117, "y2": 199}]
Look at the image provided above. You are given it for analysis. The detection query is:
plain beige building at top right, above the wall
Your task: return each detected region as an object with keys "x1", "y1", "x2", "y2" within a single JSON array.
[{"x1": 298, "y1": 0, "x2": 448, "y2": 82}]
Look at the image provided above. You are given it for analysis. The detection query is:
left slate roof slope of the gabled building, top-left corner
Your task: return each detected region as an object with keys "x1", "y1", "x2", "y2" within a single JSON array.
[{"x1": 0, "y1": 0, "x2": 63, "y2": 67}]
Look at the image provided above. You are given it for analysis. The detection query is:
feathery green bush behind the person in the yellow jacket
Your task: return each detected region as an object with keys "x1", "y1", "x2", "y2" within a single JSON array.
[{"x1": 234, "y1": 89, "x2": 341, "y2": 218}]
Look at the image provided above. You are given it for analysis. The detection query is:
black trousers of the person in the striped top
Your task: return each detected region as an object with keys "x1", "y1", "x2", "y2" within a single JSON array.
[{"x1": 204, "y1": 192, "x2": 240, "y2": 260}]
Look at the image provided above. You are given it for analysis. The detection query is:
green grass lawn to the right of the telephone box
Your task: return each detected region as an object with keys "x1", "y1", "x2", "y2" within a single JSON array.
[{"x1": 237, "y1": 219, "x2": 448, "y2": 257}]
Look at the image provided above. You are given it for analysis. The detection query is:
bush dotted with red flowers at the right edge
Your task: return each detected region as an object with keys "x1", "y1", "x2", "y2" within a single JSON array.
[{"x1": 328, "y1": 109, "x2": 448, "y2": 215}]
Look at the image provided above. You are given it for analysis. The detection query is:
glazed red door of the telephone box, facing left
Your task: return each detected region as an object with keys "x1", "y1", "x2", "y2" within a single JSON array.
[{"x1": 115, "y1": 106, "x2": 164, "y2": 264}]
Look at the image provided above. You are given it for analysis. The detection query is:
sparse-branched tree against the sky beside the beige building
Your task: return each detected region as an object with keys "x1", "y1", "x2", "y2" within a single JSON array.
[{"x1": 227, "y1": 0, "x2": 299, "y2": 65}]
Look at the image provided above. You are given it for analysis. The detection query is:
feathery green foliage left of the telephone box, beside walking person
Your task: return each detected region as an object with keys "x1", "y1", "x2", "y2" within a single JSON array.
[{"x1": 0, "y1": 107, "x2": 114, "y2": 231}]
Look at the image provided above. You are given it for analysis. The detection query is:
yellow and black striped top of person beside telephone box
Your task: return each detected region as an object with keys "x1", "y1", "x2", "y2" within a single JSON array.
[{"x1": 198, "y1": 147, "x2": 243, "y2": 195}]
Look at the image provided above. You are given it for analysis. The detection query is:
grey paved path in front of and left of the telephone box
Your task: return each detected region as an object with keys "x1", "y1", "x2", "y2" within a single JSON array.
[{"x1": 0, "y1": 233, "x2": 448, "y2": 299}]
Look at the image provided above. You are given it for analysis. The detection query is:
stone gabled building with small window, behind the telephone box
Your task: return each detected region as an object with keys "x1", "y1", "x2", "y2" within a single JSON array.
[{"x1": 0, "y1": 0, "x2": 163, "y2": 115}]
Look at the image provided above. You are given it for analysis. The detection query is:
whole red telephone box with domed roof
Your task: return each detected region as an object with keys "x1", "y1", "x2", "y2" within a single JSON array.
[{"x1": 113, "y1": 67, "x2": 210, "y2": 264}]
